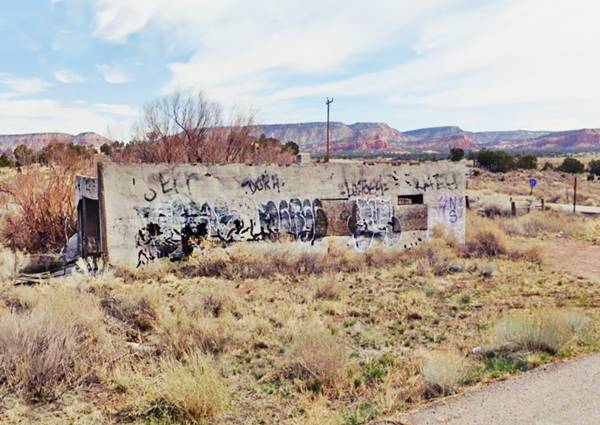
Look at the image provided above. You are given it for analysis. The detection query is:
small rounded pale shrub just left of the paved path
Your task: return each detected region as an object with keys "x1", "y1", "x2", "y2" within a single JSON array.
[{"x1": 421, "y1": 351, "x2": 469, "y2": 396}]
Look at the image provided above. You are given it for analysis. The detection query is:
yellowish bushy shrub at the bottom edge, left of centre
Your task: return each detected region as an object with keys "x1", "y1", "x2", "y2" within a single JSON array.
[{"x1": 143, "y1": 352, "x2": 229, "y2": 423}]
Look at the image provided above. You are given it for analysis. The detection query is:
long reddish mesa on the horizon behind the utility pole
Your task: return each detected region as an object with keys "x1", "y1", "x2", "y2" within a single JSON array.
[{"x1": 255, "y1": 122, "x2": 600, "y2": 155}]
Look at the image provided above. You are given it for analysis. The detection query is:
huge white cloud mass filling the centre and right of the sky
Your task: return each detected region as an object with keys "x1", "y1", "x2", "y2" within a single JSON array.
[{"x1": 84, "y1": 0, "x2": 600, "y2": 130}]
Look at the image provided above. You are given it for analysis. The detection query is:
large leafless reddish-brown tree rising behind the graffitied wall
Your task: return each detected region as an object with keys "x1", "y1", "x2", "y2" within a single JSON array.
[{"x1": 113, "y1": 92, "x2": 292, "y2": 164}]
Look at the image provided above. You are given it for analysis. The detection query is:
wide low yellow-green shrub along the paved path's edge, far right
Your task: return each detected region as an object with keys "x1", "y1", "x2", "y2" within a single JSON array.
[{"x1": 491, "y1": 310, "x2": 591, "y2": 354}]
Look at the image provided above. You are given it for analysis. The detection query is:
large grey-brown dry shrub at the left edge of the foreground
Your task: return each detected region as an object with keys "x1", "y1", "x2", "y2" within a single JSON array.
[{"x1": 0, "y1": 289, "x2": 115, "y2": 401}]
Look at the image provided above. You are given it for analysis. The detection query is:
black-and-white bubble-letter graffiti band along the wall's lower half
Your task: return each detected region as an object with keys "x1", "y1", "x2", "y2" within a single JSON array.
[{"x1": 131, "y1": 198, "x2": 414, "y2": 267}]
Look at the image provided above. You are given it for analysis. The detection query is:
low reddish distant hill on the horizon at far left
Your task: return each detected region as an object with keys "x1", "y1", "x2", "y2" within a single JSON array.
[{"x1": 0, "y1": 132, "x2": 110, "y2": 152}]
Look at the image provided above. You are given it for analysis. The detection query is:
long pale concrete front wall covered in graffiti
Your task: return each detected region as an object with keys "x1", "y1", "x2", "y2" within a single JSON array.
[{"x1": 99, "y1": 162, "x2": 465, "y2": 267}]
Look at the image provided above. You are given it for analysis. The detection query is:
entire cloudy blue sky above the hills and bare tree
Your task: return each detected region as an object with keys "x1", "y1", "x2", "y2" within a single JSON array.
[{"x1": 0, "y1": 0, "x2": 600, "y2": 139}]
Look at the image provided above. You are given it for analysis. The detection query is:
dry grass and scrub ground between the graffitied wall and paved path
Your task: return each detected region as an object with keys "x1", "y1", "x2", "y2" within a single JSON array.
[{"x1": 0, "y1": 212, "x2": 600, "y2": 424}]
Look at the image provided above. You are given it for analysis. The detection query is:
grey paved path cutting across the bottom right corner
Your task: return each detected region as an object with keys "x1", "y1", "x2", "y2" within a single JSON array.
[{"x1": 400, "y1": 354, "x2": 600, "y2": 425}]
